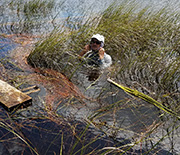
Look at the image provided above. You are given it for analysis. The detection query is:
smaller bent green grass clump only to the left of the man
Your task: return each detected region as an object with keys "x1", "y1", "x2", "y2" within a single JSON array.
[{"x1": 28, "y1": 15, "x2": 102, "y2": 78}]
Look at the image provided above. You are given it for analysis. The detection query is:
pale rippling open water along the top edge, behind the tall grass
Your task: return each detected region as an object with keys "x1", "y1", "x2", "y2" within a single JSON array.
[{"x1": 0, "y1": 0, "x2": 179, "y2": 35}]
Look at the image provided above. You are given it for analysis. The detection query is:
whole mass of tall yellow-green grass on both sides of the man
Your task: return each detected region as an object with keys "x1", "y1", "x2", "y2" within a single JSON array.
[{"x1": 28, "y1": 3, "x2": 180, "y2": 109}]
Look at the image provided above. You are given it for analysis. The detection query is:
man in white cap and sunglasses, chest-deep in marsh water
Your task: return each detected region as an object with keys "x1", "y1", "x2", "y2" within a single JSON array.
[{"x1": 80, "y1": 34, "x2": 112, "y2": 69}]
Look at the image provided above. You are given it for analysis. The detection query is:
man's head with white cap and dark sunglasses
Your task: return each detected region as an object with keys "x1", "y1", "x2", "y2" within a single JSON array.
[{"x1": 90, "y1": 34, "x2": 104, "y2": 51}]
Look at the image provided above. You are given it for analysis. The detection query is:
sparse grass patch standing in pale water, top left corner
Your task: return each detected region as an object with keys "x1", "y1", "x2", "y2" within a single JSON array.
[{"x1": 0, "y1": 0, "x2": 56, "y2": 34}]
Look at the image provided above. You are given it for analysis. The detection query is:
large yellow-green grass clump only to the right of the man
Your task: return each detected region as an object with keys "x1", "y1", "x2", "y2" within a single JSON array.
[{"x1": 97, "y1": 1, "x2": 180, "y2": 110}]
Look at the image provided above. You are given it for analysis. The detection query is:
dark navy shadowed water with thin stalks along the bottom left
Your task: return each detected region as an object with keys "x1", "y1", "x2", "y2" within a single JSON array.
[{"x1": 0, "y1": 101, "x2": 174, "y2": 155}]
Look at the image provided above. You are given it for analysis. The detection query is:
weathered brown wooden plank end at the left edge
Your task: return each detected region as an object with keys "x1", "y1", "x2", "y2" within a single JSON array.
[{"x1": 0, "y1": 80, "x2": 32, "y2": 109}]
